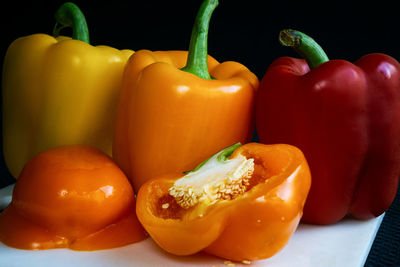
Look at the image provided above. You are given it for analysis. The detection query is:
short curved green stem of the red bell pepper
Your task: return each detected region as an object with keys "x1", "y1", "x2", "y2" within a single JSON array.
[{"x1": 279, "y1": 29, "x2": 329, "y2": 69}]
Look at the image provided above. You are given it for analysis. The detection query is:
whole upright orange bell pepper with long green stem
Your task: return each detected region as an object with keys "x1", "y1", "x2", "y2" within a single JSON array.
[{"x1": 113, "y1": 1, "x2": 258, "y2": 191}]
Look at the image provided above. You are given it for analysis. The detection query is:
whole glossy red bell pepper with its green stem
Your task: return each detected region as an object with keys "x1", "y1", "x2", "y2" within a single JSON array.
[{"x1": 256, "y1": 30, "x2": 400, "y2": 224}]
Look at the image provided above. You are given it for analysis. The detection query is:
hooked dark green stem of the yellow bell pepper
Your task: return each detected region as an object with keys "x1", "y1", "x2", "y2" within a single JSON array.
[{"x1": 53, "y1": 2, "x2": 89, "y2": 43}]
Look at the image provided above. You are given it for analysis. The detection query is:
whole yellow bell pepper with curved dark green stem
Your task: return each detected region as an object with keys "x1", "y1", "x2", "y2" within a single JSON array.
[{"x1": 2, "y1": 3, "x2": 133, "y2": 180}]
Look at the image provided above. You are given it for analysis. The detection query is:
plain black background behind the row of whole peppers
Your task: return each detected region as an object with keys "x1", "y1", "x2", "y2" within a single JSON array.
[{"x1": 0, "y1": 0, "x2": 400, "y2": 266}]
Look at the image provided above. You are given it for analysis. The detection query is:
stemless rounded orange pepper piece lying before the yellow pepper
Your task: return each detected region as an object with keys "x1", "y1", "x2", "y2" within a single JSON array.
[{"x1": 0, "y1": 145, "x2": 146, "y2": 250}]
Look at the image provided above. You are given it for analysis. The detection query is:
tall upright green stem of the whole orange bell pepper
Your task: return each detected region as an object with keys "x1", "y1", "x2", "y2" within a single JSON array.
[{"x1": 181, "y1": 0, "x2": 218, "y2": 79}]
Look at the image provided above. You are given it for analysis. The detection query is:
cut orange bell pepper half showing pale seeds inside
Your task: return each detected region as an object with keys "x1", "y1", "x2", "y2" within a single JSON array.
[{"x1": 136, "y1": 143, "x2": 311, "y2": 261}]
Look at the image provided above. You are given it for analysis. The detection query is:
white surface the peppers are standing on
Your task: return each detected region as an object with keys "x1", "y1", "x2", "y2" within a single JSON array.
[{"x1": 0, "y1": 184, "x2": 384, "y2": 267}]
